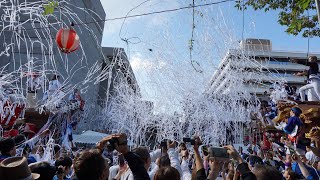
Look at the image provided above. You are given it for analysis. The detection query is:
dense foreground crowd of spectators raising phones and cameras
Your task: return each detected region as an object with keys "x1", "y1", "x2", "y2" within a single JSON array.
[{"x1": 0, "y1": 128, "x2": 320, "y2": 180}]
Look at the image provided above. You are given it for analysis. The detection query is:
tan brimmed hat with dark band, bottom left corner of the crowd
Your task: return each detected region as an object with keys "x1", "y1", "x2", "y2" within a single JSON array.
[{"x1": 0, "y1": 157, "x2": 40, "y2": 180}]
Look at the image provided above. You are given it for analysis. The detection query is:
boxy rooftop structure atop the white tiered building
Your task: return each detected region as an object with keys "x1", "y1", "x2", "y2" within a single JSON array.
[{"x1": 240, "y1": 39, "x2": 272, "y2": 51}]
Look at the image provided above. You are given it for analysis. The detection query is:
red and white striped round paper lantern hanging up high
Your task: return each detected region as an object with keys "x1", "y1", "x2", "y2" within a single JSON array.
[{"x1": 56, "y1": 28, "x2": 80, "y2": 53}]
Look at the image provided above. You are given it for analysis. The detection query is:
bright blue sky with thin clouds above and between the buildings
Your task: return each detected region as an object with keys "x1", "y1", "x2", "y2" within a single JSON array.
[{"x1": 101, "y1": 0, "x2": 320, "y2": 111}]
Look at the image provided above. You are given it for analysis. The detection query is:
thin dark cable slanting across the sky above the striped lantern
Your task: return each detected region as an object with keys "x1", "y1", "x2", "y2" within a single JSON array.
[{"x1": 4, "y1": 0, "x2": 235, "y2": 31}]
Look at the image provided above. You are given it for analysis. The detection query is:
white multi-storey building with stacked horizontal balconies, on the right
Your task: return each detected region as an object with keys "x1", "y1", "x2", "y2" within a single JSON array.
[{"x1": 206, "y1": 39, "x2": 320, "y2": 96}]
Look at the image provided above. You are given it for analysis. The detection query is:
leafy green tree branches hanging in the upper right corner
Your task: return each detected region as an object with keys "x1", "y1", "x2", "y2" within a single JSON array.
[{"x1": 236, "y1": 0, "x2": 320, "y2": 37}]
